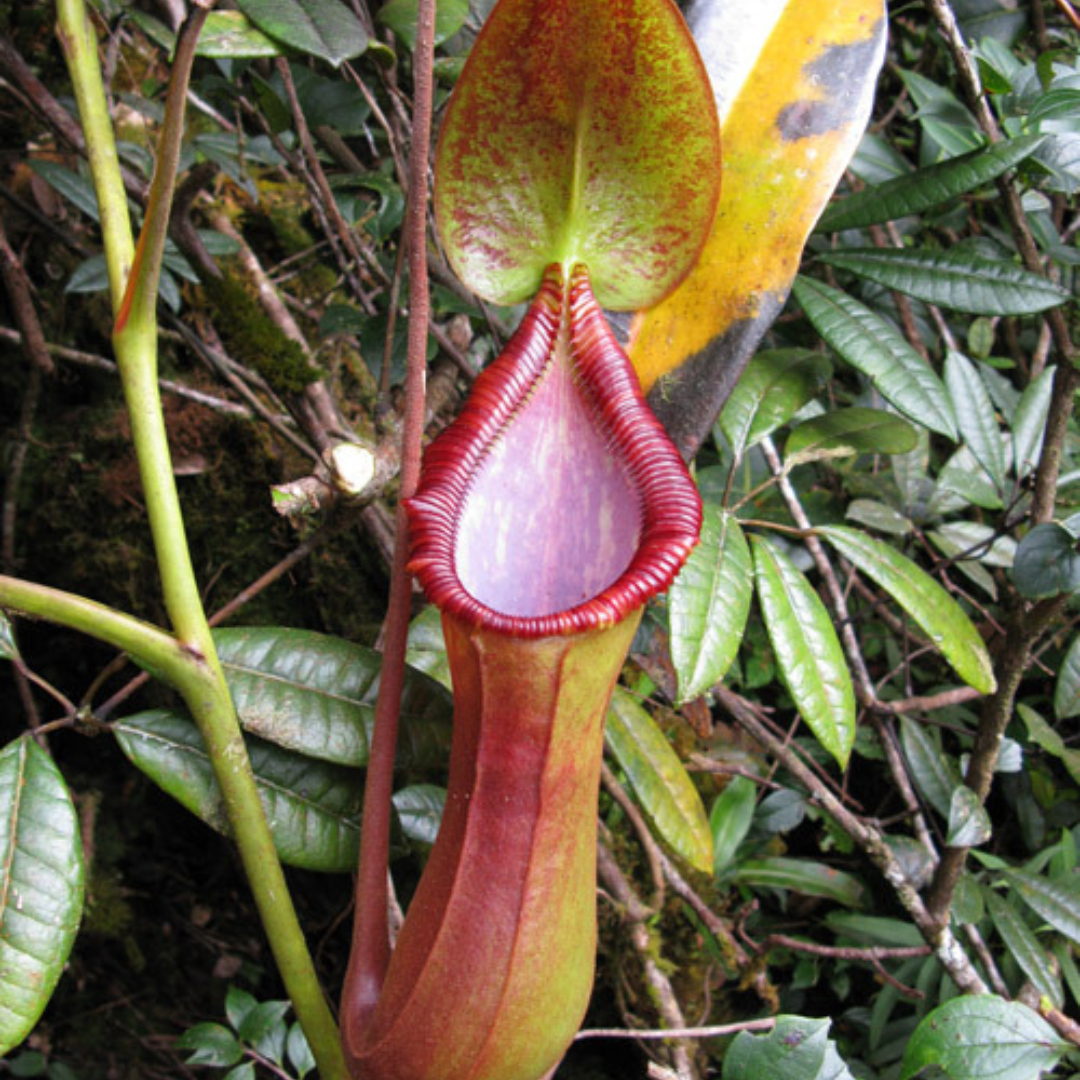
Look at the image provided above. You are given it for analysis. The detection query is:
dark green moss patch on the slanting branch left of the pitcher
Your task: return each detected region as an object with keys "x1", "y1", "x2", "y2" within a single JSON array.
[{"x1": 205, "y1": 272, "x2": 322, "y2": 395}]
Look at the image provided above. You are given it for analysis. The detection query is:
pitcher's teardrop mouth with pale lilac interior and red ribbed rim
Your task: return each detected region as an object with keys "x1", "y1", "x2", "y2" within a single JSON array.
[{"x1": 406, "y1": 265, "x2": 701, "y2": 637}]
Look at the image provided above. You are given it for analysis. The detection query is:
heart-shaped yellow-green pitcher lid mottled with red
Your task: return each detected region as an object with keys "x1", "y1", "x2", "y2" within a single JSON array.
[{"x1": 434, "y1": 0, "x2": 719, "y2": 310}]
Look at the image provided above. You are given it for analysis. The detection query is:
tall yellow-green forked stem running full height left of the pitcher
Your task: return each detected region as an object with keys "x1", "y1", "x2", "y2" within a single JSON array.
[{"x1": 53, "y1": 0, "x2": 349, "y2": 1080}]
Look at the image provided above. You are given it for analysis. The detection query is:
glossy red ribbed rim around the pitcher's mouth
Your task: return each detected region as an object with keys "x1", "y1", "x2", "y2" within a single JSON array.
[{"x1": 407, "y1": 266, "x2": 701, "y2": 637}]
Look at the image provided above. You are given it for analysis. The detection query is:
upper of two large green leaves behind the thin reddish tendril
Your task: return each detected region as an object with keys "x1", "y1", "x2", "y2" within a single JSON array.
[{"x1": 214, "y1": 626, "x2": 454, "y2": 768}]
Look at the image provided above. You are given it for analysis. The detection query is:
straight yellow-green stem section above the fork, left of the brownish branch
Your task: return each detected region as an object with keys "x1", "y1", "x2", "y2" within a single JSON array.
[{"x1": 56, "y1": 0, "x2": 135, "y2": 316}]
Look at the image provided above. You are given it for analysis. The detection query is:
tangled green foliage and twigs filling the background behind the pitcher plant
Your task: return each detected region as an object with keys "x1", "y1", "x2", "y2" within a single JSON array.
[{"x1": 6, "y1": 0, "x2": 1080, "y2": 1080}]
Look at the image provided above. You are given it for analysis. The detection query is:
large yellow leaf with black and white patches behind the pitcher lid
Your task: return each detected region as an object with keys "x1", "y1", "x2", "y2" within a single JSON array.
[{"x1": 630, "y1": 0, "x2": 886, "y2": 458}]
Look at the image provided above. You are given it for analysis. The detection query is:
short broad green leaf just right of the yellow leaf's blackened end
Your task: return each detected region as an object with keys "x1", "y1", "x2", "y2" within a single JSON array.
[{"x1": 719, "y1": 349, "x2": 832, "y2": 459}]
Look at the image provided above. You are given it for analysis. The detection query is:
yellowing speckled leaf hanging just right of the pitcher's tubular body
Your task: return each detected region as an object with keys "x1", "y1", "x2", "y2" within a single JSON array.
[{"x1": 604, "y1": 687, "x2": 713, "y2": 874}]
